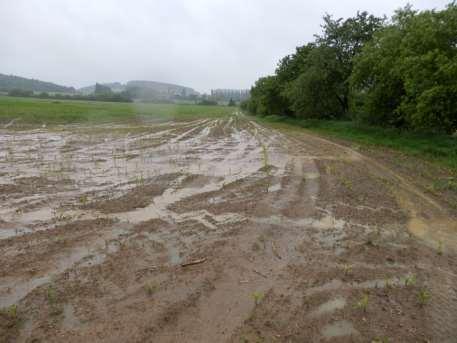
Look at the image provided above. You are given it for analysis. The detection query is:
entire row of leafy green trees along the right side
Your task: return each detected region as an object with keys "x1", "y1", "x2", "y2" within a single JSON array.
[{"x1": 242, "y1": 2, "x2": 457, "y2": 133}]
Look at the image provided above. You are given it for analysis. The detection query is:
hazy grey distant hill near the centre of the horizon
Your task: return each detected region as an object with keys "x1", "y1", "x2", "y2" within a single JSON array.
[{"x1": 78, "y1": 80, "x2": 199, "y2": 100}]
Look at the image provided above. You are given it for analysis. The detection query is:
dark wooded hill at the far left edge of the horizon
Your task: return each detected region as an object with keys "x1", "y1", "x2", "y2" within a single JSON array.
[{"x1": 0, "y1": 74, "x2": 76, "y2": 93}]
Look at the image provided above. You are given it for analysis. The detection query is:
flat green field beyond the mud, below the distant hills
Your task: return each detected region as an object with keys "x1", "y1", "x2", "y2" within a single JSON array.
[{"x1": 0, "y1": 96, "x2": 234, "y2": 125}]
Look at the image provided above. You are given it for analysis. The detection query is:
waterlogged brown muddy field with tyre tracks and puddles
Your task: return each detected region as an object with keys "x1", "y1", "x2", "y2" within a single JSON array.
[{"x1": 0, "y1": 115, "x2": 457, "y2": 342}]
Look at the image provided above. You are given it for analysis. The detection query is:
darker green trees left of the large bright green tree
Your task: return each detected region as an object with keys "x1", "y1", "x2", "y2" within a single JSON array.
[{"x1": 247, "y1": 12, "x2": 384, "y2": 119}]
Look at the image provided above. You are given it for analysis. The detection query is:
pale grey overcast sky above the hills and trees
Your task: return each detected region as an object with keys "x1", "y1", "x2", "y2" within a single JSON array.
[{"x1": 0, "y1": 0, "x2": 449, "y2": 92}]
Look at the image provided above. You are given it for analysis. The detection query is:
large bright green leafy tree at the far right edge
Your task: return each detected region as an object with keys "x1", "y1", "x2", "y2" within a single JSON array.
[{"x1": 352, "y1": 3, "x2": 457, "y2": 132}]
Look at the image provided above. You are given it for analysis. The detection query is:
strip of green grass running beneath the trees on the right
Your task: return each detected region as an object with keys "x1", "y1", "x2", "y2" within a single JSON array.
[{"x1": 253, "y1": 116, "x2": 457, "y2": 173}]
